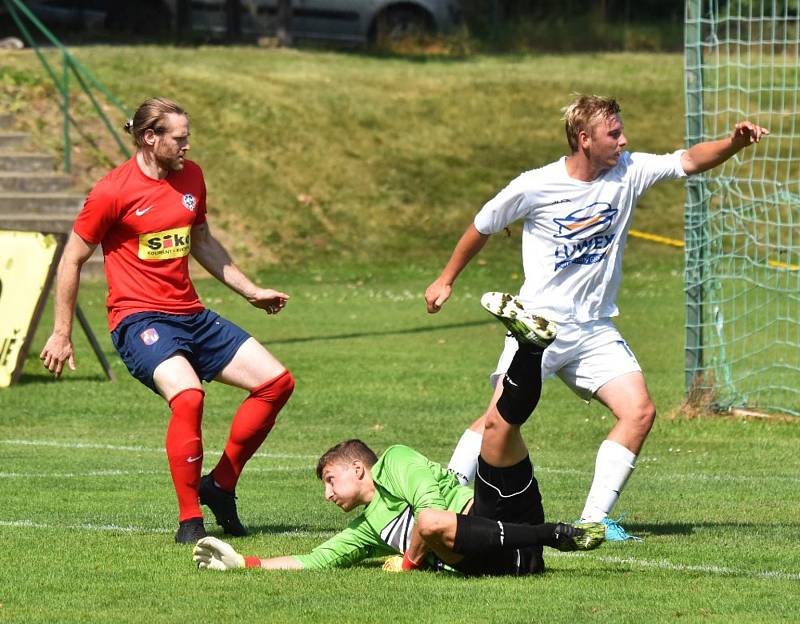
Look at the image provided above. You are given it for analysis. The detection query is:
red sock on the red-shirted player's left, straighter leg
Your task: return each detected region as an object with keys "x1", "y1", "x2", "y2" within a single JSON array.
[{"x1": 166, "y1": 388, "x2": 205, "y2": 522}]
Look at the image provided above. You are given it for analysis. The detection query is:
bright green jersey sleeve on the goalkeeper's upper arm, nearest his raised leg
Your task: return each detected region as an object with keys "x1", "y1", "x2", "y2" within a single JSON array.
[{"x1": 383, "y1": 445, "x2": 447, "y2": 518}]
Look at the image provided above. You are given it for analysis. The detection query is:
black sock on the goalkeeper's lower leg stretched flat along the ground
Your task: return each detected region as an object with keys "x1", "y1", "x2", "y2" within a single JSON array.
[{"x1": 453, "y1": 514, "x2": 556, "y2": 556}]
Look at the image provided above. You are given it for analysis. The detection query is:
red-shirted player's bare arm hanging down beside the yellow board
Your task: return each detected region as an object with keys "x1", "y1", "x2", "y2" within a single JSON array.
[{"x1": 39, "y1": 232, "x2": 97, "y2": 379}]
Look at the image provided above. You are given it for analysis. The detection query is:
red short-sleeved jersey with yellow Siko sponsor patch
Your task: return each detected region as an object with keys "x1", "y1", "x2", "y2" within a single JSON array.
[{"x1": 73, "y1": 156, "x2": 206, "y2": 331}]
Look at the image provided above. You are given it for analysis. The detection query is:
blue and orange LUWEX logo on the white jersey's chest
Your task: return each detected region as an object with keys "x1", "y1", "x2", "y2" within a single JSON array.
[{"x1": 553, "y1": 202, "x2": 619, "y2": 271}]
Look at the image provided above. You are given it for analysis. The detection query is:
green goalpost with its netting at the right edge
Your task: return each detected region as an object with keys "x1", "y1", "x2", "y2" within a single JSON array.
[{"x1": 684, "y1": 0, "x2": 800, "y2": 416}]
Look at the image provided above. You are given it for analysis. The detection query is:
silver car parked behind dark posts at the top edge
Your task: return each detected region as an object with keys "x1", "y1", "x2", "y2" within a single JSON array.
[{"x1": 162, "y1": 0, "x2": 461, "y2": 43}]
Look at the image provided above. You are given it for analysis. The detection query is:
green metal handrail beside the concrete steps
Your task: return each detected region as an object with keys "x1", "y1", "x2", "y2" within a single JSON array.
[{"x1": 2, "y1": 0, "x2": 131, "y2": 173}]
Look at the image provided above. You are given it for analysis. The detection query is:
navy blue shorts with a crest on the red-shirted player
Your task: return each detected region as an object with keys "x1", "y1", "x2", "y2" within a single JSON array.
[{"x1": 111, "y1": 310, "x2": 250, "y2": 393}]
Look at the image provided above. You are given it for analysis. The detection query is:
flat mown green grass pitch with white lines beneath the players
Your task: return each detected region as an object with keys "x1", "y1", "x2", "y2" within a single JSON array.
[{"x1": 0, "y1": 246, "x2": 800, "y2": 623}]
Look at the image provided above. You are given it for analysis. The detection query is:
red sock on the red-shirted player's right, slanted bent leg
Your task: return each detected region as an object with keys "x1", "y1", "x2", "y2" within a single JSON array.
[{"x1": 212, "y1": 370, "x2": 294, "y2": 492}]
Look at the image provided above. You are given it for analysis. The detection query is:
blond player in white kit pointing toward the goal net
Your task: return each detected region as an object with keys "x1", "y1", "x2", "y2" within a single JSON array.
[{"x1": 425, "y1": 96, "x2": 769, "y2": 540}]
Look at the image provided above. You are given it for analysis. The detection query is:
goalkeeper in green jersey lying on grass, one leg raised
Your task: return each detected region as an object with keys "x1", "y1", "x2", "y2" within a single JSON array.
[{"x1": 193, "y1": 293, "x2": 605, "y2": 575}]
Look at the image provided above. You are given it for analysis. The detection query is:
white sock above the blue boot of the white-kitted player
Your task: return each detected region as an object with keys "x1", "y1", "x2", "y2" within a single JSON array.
[{"x1": 581, "y1": 440, "x2": 636, "y2": 522}]
